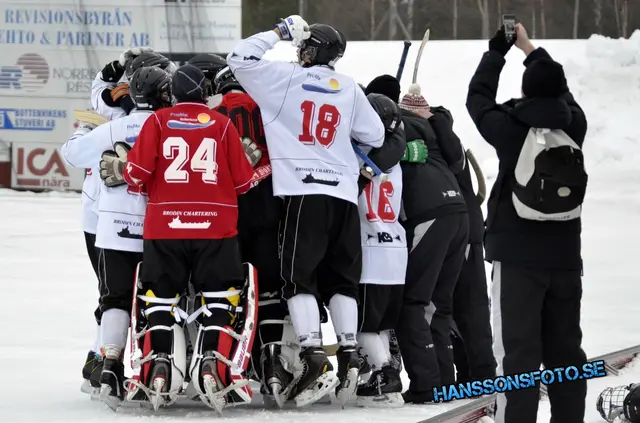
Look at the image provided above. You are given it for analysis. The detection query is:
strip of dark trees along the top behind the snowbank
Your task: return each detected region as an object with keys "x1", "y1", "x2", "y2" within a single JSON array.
[{"x1": 242, "y1": 0, "x2": 640, "y2": 41}]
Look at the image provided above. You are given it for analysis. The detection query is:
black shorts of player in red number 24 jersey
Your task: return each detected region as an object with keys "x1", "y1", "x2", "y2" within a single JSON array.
[{"x1": 140, "y1": 237, "x2": 244, "y2": 298}]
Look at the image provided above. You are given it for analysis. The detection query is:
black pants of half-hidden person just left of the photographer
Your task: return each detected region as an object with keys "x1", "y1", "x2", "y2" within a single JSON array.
[{"x1": 452, "y1": 243, "x2": 496, "y2": 382}]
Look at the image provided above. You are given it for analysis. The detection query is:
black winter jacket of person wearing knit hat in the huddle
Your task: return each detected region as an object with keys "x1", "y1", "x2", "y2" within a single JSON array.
[{"x1": 401, "y1": 107, "x2": 467, "y2": 227}]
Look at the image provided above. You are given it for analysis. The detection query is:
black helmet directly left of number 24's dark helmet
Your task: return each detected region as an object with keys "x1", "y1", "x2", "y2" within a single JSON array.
[{"x1": 129, "y1": 67, "x2": 172, "y2": 110}]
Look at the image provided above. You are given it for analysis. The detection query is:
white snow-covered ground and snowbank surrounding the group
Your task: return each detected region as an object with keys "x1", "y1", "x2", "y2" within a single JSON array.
[{"x1": 0, "y1": 32, "x2": 640, "y2": 423}]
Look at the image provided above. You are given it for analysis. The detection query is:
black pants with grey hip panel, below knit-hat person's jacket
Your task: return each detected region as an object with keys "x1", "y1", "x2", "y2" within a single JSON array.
[{"x1": 396, "y1": 213, "x2": 469, "y2": 398}]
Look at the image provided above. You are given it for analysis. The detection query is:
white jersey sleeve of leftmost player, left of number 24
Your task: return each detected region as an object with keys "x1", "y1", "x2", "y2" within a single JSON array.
[{"x1": 60, "y1": 123, "x2": 113, "y2": 168}]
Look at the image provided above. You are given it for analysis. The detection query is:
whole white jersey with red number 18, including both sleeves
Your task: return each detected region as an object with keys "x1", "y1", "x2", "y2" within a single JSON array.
[{"x1": 227, "y1": 31, "x2": 384, "y2": 204}]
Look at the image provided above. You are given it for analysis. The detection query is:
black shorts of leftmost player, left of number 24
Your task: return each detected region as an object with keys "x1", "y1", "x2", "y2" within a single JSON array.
[{"x1": 98, "y1": 248, "x2": 142, "y2": 313}]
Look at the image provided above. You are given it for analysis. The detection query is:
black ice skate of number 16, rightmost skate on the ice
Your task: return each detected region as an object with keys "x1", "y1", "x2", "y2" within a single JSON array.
[{"x1": 356, "y1": 365, "x2": 404, "y2": 408}]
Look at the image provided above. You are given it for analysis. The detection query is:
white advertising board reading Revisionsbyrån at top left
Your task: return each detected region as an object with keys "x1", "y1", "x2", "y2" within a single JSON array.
[{"x1": 0, "y1": 0, "x2": 242, "y2": 98}]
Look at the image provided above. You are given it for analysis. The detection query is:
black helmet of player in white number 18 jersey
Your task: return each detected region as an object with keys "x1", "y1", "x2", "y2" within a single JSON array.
[{"x1": 298, "y1": 24, "x2": 347, "y2": 68}]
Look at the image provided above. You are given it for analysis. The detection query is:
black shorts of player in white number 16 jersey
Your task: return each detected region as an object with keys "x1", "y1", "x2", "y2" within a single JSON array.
[{"x1": 358, "y1": 283, "x2": 404, "y2": 332}]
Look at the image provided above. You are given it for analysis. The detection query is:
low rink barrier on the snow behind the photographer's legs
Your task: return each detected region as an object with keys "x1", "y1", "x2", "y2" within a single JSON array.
[{"x1": 418, "y1": 345, "x2": 640, "y2": 423}]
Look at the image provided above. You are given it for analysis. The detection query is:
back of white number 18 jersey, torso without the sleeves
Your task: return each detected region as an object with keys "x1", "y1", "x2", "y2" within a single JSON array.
[{"x1": 265, "y1": 66, "x2": 366, "y2": 201}]
